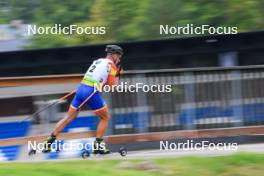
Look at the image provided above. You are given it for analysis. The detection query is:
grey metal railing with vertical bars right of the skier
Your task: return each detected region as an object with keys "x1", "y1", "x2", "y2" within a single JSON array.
[{"x1": 104, "y1": 66, "x2": 264, "y2": 134}]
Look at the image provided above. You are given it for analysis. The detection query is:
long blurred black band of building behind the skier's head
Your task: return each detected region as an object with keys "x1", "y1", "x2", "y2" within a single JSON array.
[{"x1": 0, "y1": 32, "x2": 264, "y2": 76}]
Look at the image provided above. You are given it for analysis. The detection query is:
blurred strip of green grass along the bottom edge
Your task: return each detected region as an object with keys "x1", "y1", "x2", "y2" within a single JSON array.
[{"x1": 0, "y1": 154, "x2": 264, "y2": 176}]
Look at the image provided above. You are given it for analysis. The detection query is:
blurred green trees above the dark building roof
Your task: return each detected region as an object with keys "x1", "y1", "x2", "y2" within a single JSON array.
[{"x1": 0, "y1": 0, "x2": 264, "y2": 48}]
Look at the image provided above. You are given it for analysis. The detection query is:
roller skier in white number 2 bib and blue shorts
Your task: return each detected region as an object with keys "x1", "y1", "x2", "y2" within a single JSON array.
[{"x1": 43, "y1": 45, "x2": 123, "y2": 154}]
